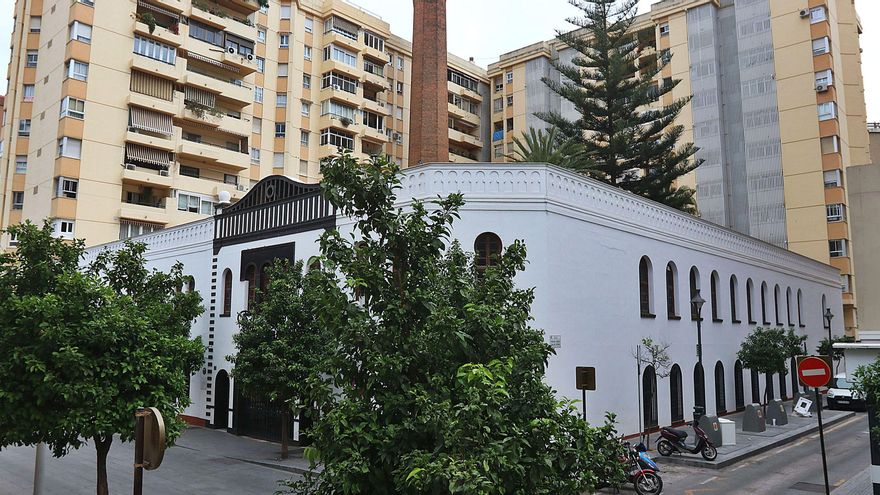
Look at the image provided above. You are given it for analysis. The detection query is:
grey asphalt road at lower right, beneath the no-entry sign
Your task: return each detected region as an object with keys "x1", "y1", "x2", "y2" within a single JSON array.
[{"x1": 648, "y1": 413, "x2": 871, "y2": 495}]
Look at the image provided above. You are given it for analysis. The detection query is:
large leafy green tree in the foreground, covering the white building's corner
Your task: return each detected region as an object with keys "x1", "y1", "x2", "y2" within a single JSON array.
[{"x1": 291, "y1": 154, "x2": 622, "y2": 495}]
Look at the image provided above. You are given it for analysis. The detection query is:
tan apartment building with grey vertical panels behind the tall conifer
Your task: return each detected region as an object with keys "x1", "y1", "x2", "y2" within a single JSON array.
[{"x1": 488, "y1": 0, "x2": 869, "y2": 333}]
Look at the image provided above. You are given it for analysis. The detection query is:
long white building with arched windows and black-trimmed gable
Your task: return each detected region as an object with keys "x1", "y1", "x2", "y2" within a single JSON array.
[{"x1": 84, "y1": 164, "x2": 842, "y2": 436}]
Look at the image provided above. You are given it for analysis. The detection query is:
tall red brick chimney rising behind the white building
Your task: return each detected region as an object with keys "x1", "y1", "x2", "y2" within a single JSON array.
[{"x1": 409, "y1": 0, "x2": 449, "y2": 166}]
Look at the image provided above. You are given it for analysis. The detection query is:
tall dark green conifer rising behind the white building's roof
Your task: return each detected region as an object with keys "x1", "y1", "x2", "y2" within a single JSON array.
[{"x1": 537, "y1": 0, "x2": 700, "y2": 212}]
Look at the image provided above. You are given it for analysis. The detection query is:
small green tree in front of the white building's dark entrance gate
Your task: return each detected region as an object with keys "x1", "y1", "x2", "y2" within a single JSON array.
[{"x1": 228, "y1": 259, "x2": 330, "y2": 459}]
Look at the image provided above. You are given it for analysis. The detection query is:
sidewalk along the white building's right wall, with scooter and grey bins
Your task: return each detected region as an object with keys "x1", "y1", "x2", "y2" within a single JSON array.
[{"x1": 651, "y1": 403, "x2": 855, "y2": 469}]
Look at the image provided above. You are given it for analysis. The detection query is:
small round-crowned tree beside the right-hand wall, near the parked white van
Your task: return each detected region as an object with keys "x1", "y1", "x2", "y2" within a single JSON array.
[{"x1": 736, "y1": 327, "x2": 807, "y2": 413}]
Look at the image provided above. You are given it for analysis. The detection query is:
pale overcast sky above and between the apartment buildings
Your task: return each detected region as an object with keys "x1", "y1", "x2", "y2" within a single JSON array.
[{"x1": 0, "y1": 0, "x2": 880, "y2": 122}]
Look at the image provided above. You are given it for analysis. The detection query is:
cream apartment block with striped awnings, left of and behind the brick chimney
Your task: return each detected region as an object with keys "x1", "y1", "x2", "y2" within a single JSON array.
[{"x1": 0, "y1": 0, "x2": 489, "y2": 249}]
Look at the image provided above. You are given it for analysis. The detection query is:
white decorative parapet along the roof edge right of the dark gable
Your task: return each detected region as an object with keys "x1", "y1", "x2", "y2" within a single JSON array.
[{"x1": 398, "y1": 163, "x2": 840, "y2": 285}]
